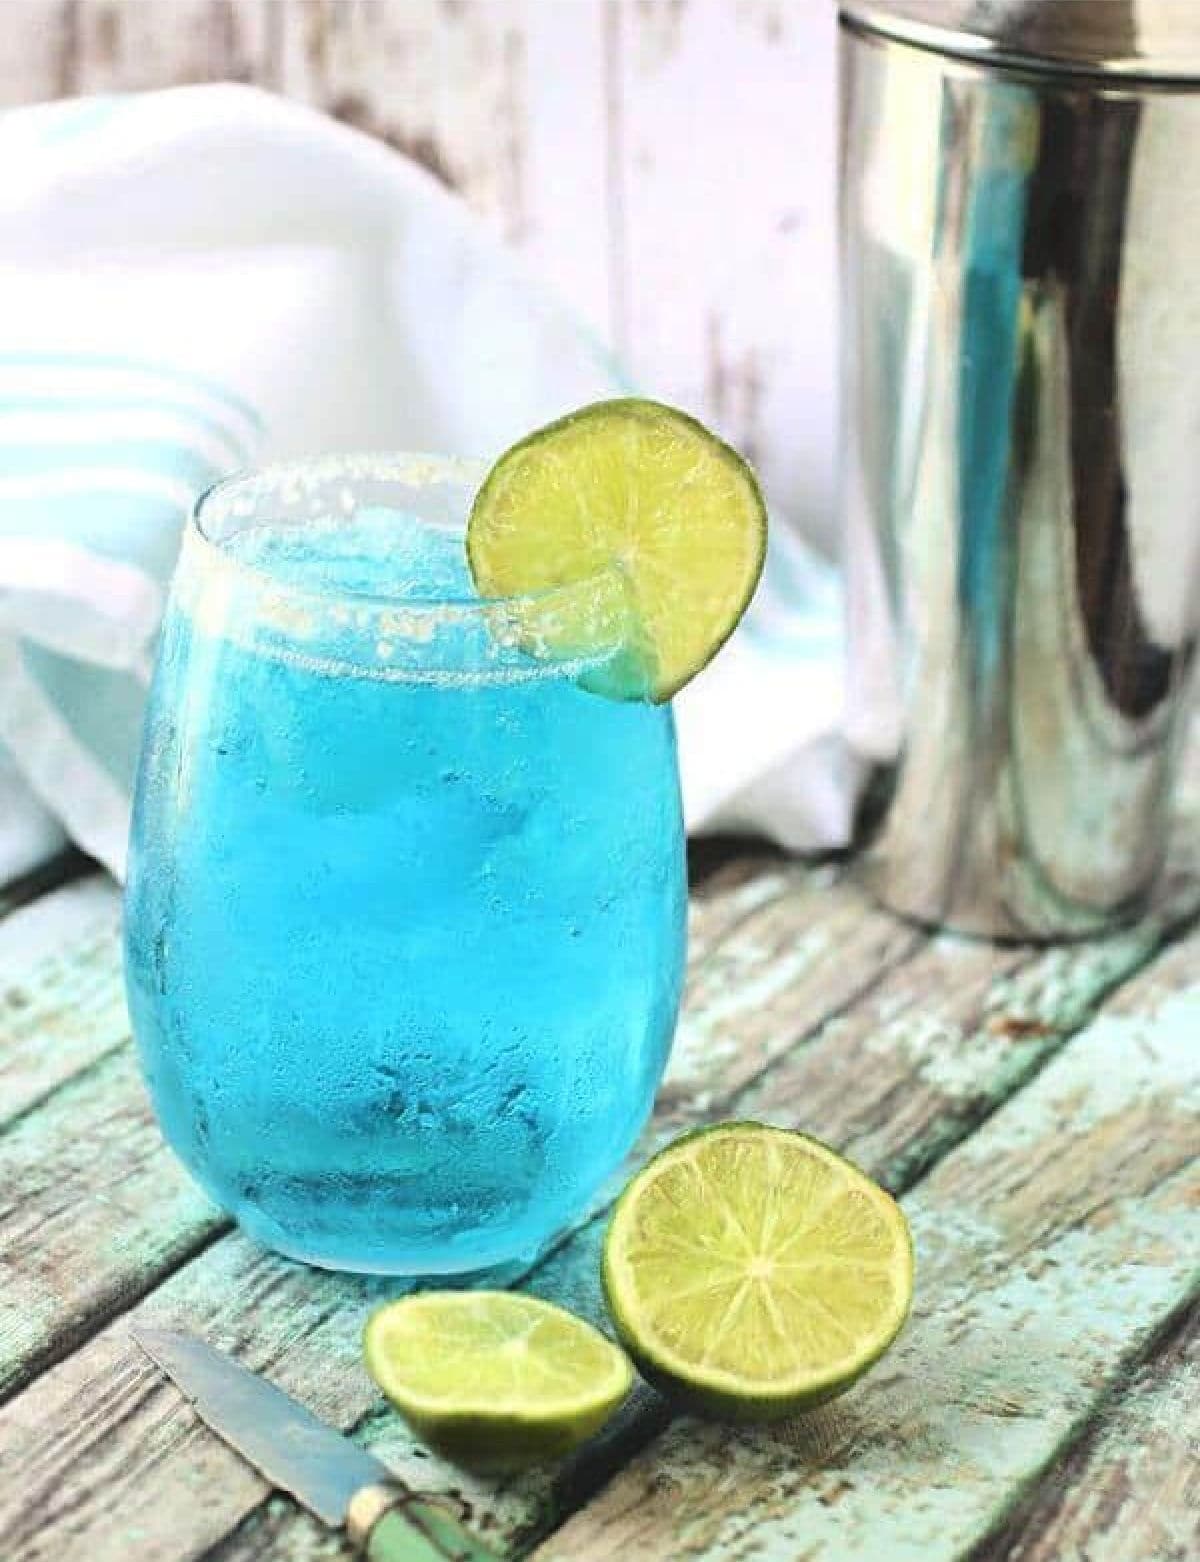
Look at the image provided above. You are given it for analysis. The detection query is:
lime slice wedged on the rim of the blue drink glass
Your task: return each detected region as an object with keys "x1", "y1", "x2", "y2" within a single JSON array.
[{"x1": 467, "y1": 398, "x2": 767, "y2": 700}]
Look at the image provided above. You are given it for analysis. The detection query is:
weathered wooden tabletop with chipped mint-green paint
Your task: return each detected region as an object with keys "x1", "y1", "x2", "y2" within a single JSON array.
[{"x1": 0, "y1": 746, "x2": 1200, "y2": 1562}]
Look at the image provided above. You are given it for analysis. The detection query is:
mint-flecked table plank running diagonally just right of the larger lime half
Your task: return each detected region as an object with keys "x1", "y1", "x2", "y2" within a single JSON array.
[{"x1": 534, "y1": 934, "x2": 1200, "y2": 1562}]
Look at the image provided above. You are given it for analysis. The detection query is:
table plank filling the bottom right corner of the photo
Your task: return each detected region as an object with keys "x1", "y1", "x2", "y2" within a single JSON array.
[{"x1": 972, "y1": 1306, "x2": 1200, "y2": 1562}]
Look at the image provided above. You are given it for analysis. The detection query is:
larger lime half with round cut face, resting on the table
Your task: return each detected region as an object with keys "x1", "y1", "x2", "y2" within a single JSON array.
[{"x1": 603, "y1": 1123, "x2": 913, "y2": 1421}]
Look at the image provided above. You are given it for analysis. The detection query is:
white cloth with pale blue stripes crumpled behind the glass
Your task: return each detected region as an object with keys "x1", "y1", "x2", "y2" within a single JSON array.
[{"x1": 0, "y1": 84, "x2": 853, "y2": 876}]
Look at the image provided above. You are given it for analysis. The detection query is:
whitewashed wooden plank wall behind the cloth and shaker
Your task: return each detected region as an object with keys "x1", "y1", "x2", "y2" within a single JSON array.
[{"x1": 0, "y1": 0, "x2": 834, "y2": 544}]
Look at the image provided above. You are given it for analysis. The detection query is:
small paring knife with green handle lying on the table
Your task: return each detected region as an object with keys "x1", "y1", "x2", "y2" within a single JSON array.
[{"x1": 130, "y1": 1326, "x2": 497, "y2": 1562}]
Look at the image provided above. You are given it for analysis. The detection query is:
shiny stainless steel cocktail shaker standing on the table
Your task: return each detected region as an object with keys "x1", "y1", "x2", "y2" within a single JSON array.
[{"x1": 841, "y1": 0, "x2": 1200, "y2": 937}]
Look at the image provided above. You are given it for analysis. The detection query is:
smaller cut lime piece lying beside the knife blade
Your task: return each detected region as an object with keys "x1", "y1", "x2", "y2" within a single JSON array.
[{"x1": 363, "y1": 1290, "x2": 633, "y2": 1470}]
